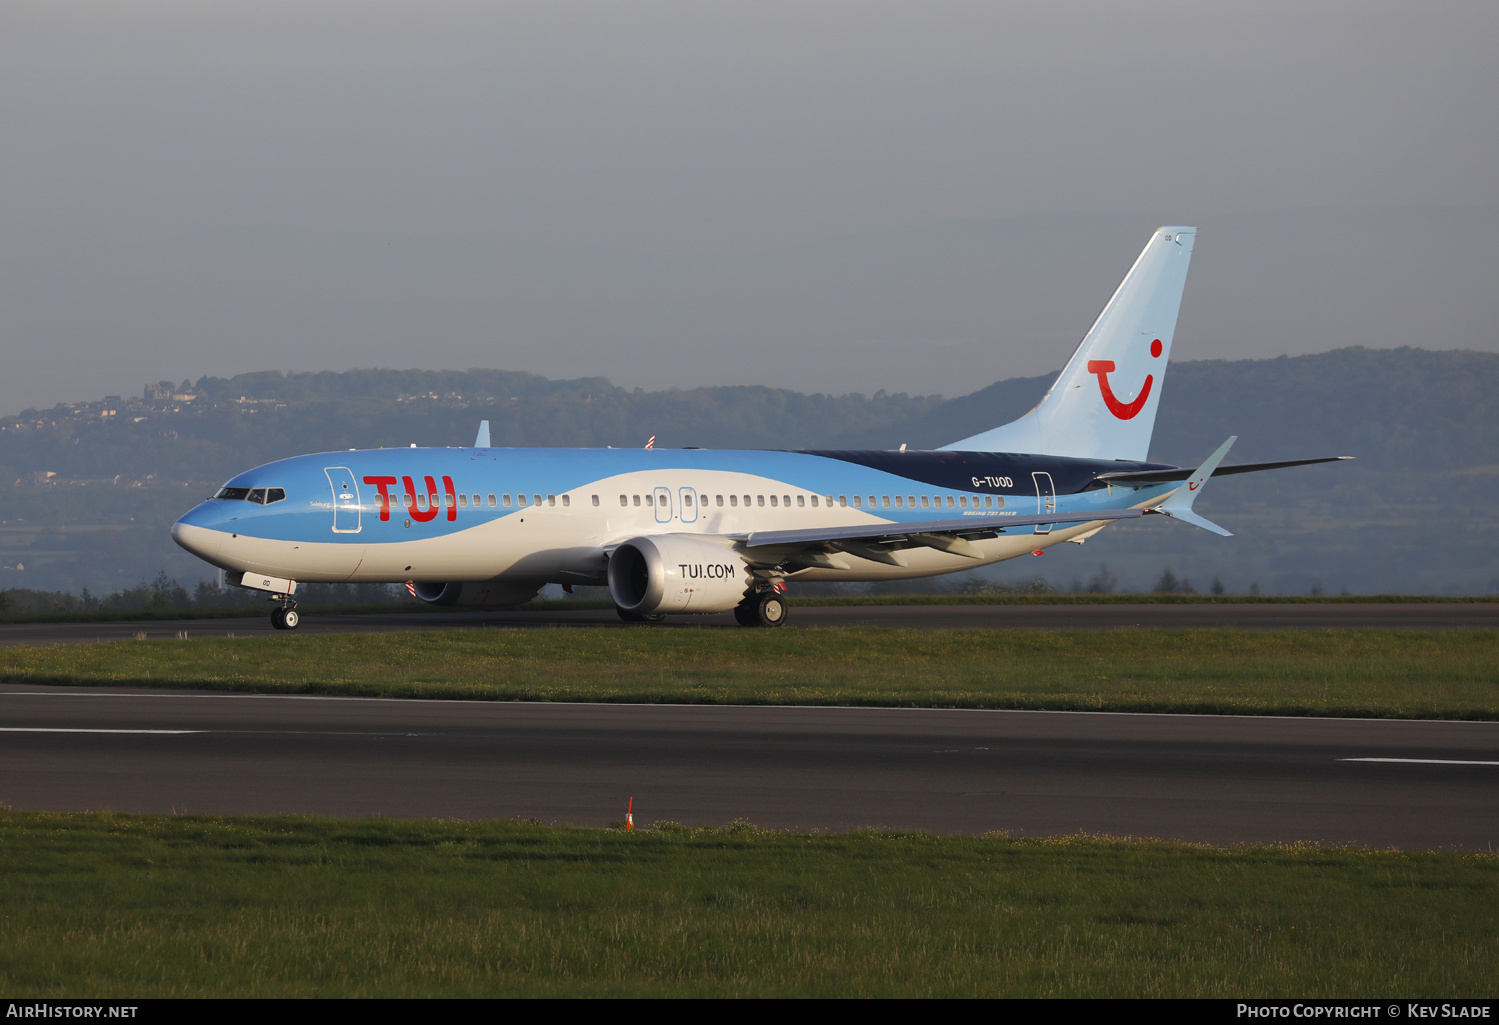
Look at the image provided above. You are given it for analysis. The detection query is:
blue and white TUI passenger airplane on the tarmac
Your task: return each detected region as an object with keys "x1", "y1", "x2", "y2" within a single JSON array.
[{"x1": 172, "y1": 226, "x2": 1351, "y2": 629}]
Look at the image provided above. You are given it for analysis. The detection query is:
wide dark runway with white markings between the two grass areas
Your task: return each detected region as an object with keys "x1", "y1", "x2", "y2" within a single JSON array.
[{"x1": 0, "y1": 685, "x2": 1499, "y2": 850}]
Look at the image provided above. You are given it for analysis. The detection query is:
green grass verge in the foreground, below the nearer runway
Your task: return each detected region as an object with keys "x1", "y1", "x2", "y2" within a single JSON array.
[{"x1": 0, "y1": 812, "x2": 1499, "y2": 998}]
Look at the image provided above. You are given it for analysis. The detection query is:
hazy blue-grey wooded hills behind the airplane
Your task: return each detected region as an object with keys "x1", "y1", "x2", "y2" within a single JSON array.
[{"x1": 0, "y1": 348, "x2": 1499, "y2": 592}]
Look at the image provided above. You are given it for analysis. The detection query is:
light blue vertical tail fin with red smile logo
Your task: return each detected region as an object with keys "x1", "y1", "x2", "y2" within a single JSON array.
[{"x1": 943, "y1": 226, "x2": 1198, "y2": 460}]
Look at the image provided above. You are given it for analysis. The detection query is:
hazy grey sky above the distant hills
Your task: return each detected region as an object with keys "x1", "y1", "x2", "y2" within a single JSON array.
[{"x1": 0, "y1": 0, "x2": 1499, "y2": 414}]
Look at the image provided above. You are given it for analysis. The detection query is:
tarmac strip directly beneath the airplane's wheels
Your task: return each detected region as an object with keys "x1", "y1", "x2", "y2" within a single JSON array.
[{"x1": 0, "y1": 601, "x2": 1499, "y2": 647}]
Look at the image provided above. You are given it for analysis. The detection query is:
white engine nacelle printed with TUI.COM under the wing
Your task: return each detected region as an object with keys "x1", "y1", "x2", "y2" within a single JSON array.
[{"x1": 609, "y1": 536, "x2": 754, "y2": 616}]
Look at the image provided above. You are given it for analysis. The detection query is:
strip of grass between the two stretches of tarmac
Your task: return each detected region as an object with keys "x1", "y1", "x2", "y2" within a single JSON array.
[{"x1": 0, "y1": 626, "x2": 1499, "y2": 719}]
